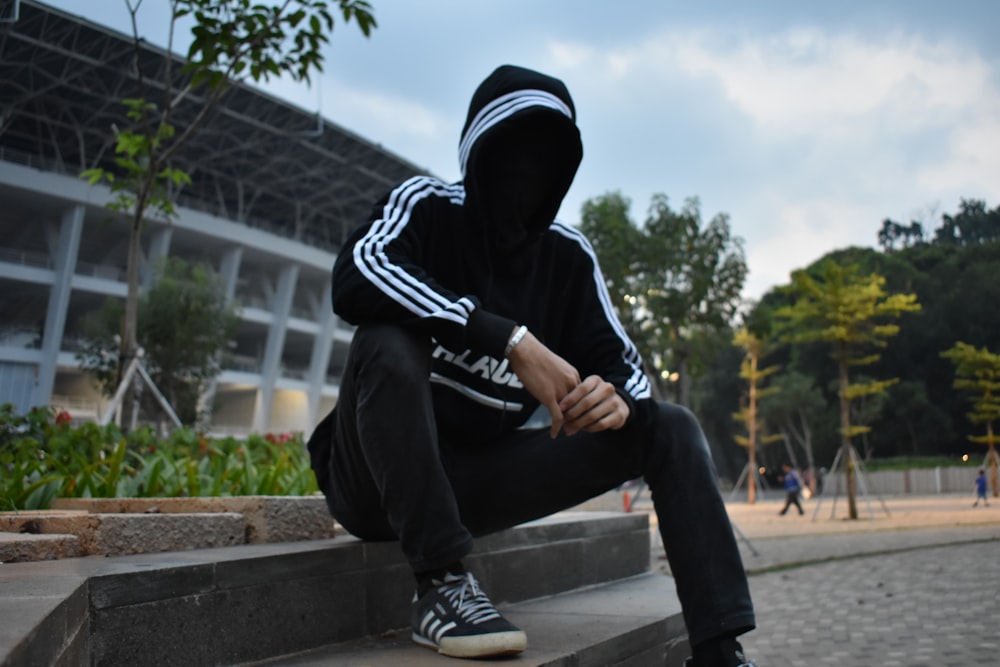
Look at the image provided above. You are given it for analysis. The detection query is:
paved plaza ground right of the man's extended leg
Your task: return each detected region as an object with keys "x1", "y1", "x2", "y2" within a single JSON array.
[{"x1": 640, "y1": 494, "x2": 1000, "y2": 667}]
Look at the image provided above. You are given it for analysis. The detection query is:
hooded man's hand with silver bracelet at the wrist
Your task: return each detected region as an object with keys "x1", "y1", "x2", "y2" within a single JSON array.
[{"x1": 508, "y1": 331, "x2": 580, "y2": 438}]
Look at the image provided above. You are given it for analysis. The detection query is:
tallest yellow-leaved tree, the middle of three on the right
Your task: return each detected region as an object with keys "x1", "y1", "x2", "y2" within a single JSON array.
[{"x1": 775, "y1": 260, "x2": 920, "y2": 519}]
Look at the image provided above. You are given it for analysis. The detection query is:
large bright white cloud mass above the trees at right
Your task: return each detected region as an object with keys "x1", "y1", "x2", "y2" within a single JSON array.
[{"x1": 549, "y1": 27, "x2": 1000, "y2": 296}]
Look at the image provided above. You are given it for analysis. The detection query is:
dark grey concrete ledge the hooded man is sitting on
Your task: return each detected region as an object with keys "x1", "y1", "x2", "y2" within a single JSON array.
[{"x1": 0, "y1": 513, "x2": 664, "y2": 667}]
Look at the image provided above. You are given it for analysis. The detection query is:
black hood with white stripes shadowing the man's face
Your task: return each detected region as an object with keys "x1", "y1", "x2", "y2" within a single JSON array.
[{"x1": 459, "y1": 65, "x2": 583, "y2": 254}]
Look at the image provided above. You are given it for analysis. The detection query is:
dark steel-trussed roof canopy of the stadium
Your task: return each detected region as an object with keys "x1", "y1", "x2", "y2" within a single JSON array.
[{"x1": 0, "y1": 0, "x2": 426, "y2": 251}]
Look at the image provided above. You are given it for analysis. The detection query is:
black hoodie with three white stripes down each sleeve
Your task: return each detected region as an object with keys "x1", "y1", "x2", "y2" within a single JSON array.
[{"x1": 333, "y1": 65, "x2": 650, "y2": 440}]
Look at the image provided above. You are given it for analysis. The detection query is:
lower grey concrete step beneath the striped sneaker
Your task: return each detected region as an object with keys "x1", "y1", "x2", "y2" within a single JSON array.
[{"x1": 247, "y1": 573, "x2": 688, "y2": 667}]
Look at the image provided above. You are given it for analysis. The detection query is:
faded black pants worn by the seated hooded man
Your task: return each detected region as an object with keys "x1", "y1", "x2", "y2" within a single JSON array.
[{"x1": 310, "y1": 325, "x2": 754, "y2": 643}]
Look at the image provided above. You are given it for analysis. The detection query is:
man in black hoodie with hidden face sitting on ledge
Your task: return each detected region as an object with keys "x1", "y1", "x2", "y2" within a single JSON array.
[{"x1": 309, "y1": 66, "x2": 754, "y2": 667}]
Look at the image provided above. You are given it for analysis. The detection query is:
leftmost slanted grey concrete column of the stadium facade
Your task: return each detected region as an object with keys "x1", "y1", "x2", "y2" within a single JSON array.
[{"x1": 33, "y1": 206, "x2": 84, "y2": 405}]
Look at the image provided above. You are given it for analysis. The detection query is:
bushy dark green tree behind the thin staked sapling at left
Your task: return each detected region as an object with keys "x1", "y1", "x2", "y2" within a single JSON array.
[{"x1": 78, "y1": 258, "x2": 237, "y2": 424}]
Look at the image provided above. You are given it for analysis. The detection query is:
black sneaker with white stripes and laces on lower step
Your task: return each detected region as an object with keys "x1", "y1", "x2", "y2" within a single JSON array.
[{"x1": 412, "y1": 572, "x2": 528, "y2": 658}]
